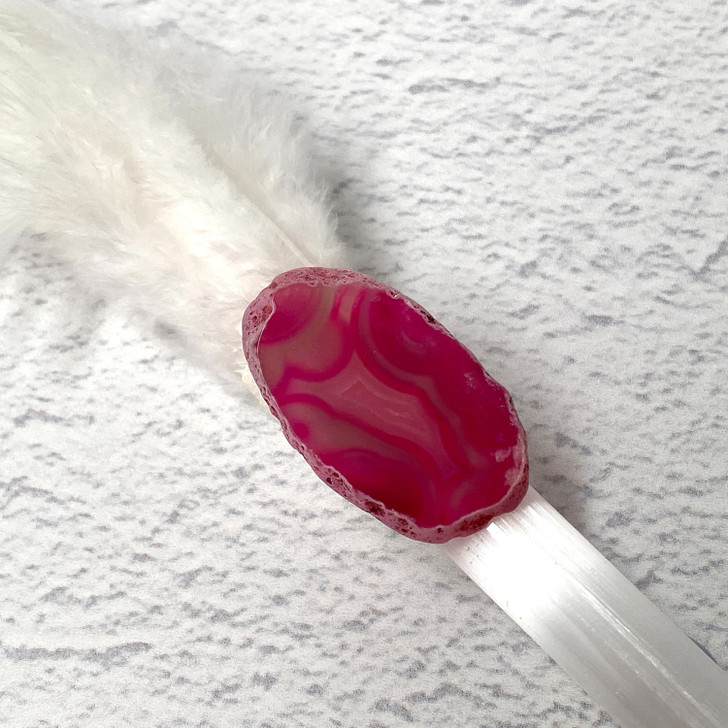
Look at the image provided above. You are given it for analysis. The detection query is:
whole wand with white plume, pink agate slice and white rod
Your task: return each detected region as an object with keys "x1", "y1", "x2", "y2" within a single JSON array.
[{"x1": 0, "y1": 2, "x2": 728, "y2": 728}]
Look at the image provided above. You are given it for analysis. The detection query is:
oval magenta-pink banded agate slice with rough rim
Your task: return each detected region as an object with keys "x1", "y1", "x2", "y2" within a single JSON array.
[{"x1": 243, "y1": 268, "x2": 528, "y2": 543}]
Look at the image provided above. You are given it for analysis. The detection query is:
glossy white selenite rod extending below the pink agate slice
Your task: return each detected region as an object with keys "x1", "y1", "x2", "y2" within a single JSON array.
[{"x1": 443, "y1": 488, "x2": 728, "y2": 728}]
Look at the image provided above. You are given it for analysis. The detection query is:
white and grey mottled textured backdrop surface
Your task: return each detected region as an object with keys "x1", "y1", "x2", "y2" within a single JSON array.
[{"x1": 0, "y1": 0, "x2": 728, "y2": 728}]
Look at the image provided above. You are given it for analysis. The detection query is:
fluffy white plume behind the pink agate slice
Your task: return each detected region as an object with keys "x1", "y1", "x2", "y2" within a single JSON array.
[{"x1": 0, "y1": 0, "x2": 341, "y2": 392}]
